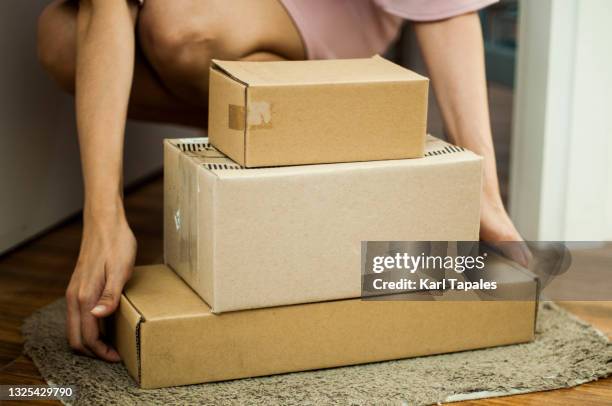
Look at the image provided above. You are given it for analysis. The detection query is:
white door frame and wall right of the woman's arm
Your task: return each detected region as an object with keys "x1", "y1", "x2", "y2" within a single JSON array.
[{"x1": 510, "y1": 0, "x2": 612, "y2": 240}]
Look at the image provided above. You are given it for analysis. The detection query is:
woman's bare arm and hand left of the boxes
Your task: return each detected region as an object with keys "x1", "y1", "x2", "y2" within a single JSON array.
[{"x1": 66, "y1": 0, "x2": 136, "y2": 361}]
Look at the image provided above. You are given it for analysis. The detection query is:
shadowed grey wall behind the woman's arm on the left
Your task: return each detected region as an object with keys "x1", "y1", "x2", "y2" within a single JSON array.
[{"x1": 0, "y1": 0, "x2": 197, "y2": 253}]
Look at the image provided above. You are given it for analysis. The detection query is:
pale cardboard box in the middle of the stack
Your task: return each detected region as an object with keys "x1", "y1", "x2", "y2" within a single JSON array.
[{"x1": 164, "y1": 137, "x2": 482, "y2": 313}]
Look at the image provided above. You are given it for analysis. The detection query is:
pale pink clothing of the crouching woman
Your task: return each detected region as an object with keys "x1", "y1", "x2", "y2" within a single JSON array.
[{"x1": 281, "y1": 0, "x2": 498, "y2": 59}]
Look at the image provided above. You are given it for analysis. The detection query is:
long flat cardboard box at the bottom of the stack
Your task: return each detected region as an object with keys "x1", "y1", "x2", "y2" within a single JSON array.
[{"x1": 111, "y1": 262, "x2": 537, "y2": 388}]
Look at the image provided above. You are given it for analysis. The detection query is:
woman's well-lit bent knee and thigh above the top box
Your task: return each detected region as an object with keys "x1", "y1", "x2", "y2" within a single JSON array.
[{"x1": 138, "y1": 0, "x2": 305, "y2": 105}]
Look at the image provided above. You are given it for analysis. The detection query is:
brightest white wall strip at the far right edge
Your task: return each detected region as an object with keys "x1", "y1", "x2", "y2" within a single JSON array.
[{"x1": 565, "y1": 0, "x2": 612, "y2": 240}]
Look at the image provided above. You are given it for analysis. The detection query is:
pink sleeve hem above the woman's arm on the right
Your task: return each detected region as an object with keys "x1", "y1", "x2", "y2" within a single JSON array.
[{"x1": 374, "y1": 0, "x2": 499, "y2": 21}]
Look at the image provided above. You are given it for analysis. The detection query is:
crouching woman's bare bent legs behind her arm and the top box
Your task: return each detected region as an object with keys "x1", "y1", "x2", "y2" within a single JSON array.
[{"x1": 38, "y1": 0, "x2": 305, "y2": 127}]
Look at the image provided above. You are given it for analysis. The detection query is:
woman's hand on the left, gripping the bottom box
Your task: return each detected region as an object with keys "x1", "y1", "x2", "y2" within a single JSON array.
[{"x1": 66, "y1": 206, "x2": 136, "y2": 362}]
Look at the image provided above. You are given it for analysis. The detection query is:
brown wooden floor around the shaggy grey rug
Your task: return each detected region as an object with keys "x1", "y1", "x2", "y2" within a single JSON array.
[{"x1": 0, "y1": 176, "x2": 612, "y2": 405}]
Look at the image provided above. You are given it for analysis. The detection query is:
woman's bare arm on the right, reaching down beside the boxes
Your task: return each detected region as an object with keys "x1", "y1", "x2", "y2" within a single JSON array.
[{"x1": 414, "y1": 13, "x2": 529, "y2": 264}]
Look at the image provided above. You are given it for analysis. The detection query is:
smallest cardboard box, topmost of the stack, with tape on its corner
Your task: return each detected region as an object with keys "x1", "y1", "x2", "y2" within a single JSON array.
[{"x1": 208, "y1": 56, "x2": 429, "y2": 167}]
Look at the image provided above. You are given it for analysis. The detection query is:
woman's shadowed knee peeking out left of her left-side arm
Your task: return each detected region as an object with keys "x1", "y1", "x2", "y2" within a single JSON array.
[{"x1": 37, "y1": 1, "x2": 76, "y2": 92}]
